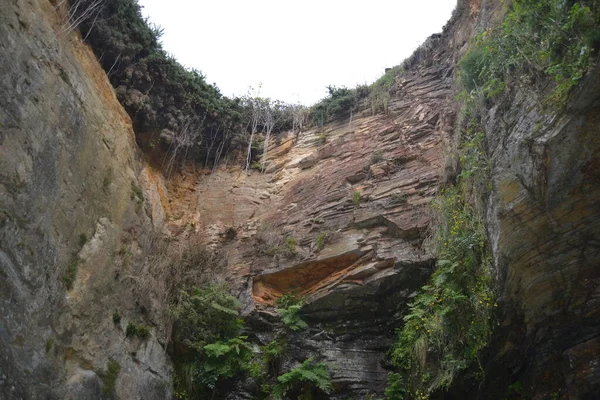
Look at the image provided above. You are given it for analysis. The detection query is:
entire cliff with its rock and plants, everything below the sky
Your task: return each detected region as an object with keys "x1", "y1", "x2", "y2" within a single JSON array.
[{"x1": 0, "y1": 0, "x2": 600, "y2": 399}]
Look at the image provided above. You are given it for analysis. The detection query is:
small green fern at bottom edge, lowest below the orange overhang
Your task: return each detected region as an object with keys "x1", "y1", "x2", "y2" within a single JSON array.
[{"x1": 273, "y1": 358, "x2": 333, "y2": 399}]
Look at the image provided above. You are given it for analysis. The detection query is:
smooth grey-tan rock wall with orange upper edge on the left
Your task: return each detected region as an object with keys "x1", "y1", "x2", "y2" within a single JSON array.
[{"x1": 0, "y1": 0, "x2": 170, "y2": 399}]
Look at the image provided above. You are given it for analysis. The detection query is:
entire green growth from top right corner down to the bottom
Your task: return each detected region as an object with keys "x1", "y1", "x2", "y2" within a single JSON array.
[{"x1": 389, "y1": 0, "x2": 600, "y2": 398}]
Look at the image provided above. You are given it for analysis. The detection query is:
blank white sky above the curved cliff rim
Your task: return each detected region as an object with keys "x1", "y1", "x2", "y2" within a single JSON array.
[{"x1": 139, "y1": 0, "x2": 456, "y2": 105}]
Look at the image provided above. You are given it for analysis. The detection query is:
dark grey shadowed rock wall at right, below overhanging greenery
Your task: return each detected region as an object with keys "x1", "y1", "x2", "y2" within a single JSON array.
[{"x1": 486, "y1": 53, "x2": 600, "y2": 399}]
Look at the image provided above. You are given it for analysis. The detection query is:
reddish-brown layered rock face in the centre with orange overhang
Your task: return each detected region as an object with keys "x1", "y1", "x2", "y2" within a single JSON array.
[{"x1": 173, "y1": 28, "x2": 454, "y2": 398}]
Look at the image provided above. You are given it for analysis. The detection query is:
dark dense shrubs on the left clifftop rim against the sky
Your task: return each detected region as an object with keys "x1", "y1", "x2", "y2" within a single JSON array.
[{"x1": 71, "y1": 0, "x2": 242, "y2": 167}]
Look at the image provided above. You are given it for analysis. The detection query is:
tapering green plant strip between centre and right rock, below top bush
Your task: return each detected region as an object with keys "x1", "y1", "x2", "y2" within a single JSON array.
[{"x1": 390, "y1": 27, "x2": 495, "y2": 399}]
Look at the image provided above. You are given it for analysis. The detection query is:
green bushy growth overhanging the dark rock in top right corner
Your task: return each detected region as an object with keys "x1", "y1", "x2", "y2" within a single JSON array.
[{"x1": 460, "y1": 0, "x2": 600, "y2": 107}]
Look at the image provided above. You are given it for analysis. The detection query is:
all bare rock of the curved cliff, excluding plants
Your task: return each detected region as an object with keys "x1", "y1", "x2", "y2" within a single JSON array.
[{"x1": 0, "y1": 0, "x2": 600, "y2": 399}]
